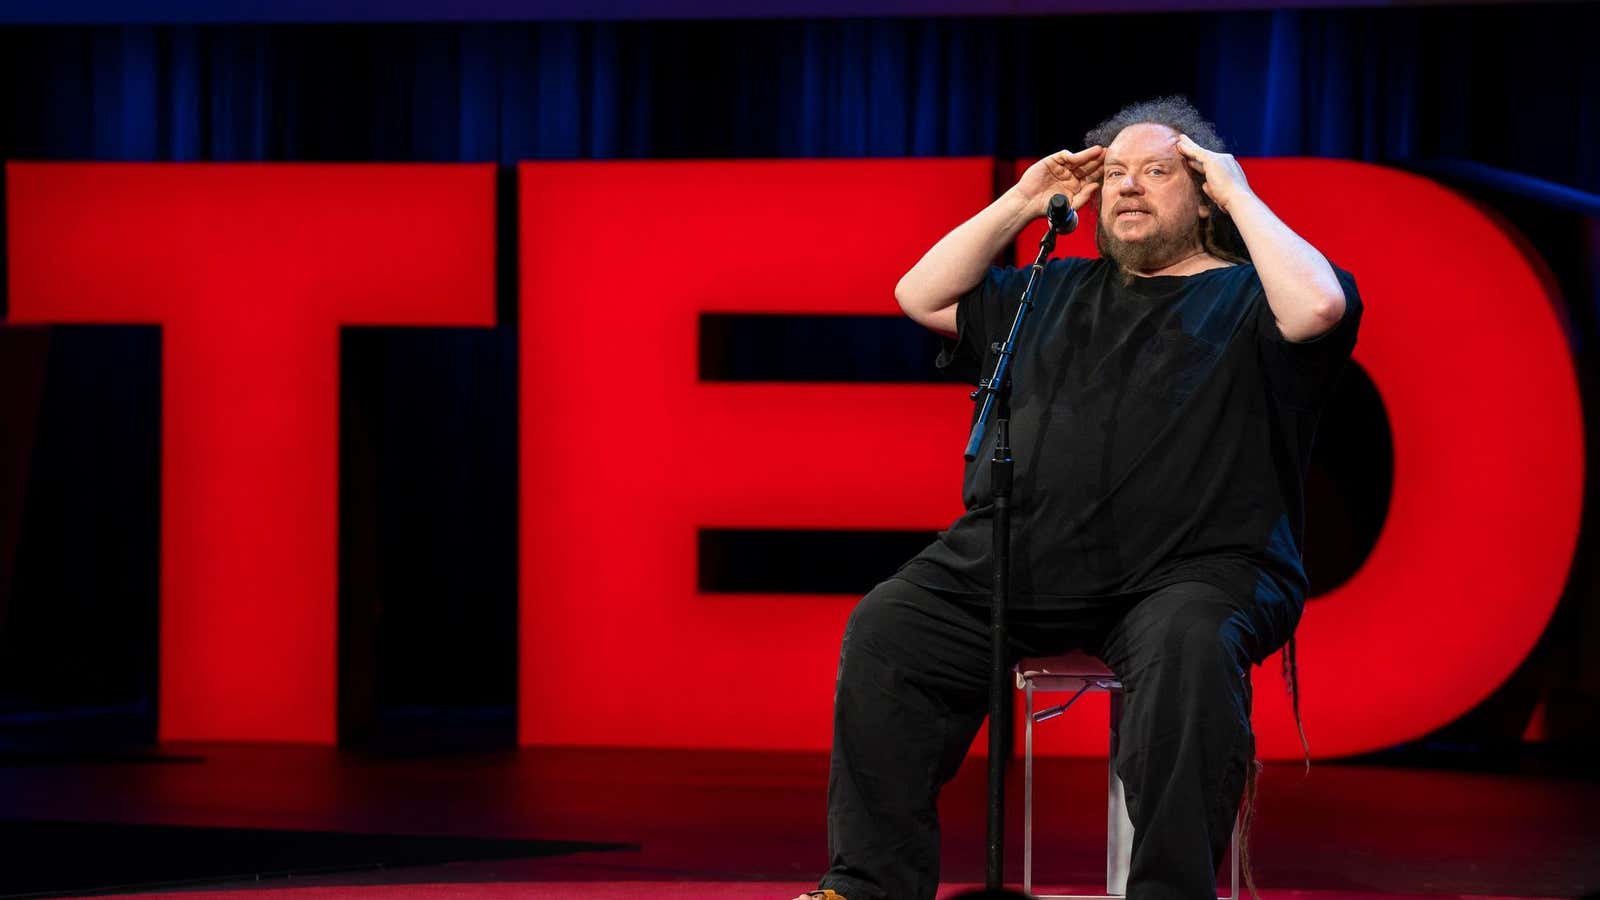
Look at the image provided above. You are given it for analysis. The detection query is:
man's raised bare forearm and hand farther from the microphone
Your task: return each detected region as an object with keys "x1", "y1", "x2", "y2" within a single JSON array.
[{"x1": 1178, "y1": 135, "x2": 1344, "y2": 341}]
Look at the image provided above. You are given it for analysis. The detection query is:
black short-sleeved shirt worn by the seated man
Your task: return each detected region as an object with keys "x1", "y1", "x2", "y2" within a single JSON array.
[{"x1": 899, "y1": 259, "x2": 1362, "y2": 624}]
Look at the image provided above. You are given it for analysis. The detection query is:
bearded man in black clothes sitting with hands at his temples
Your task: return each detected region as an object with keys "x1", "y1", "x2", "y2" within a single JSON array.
[{"x1": 793, "y1": 98, "x2": 1362, "y2": 900}]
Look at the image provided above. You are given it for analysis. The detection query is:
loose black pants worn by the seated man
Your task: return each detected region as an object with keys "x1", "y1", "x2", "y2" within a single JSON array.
[{"x1": 821, "y1": 578, "x2": 1286, "y2": 900}]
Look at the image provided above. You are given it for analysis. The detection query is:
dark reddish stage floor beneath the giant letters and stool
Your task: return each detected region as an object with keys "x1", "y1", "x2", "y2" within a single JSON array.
[{"x1": 0, "y1": 745, "x2": 1600, "y2": 900}]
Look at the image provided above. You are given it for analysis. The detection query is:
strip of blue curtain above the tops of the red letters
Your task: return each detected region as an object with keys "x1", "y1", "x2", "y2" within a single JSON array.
[{"x1": 0, "y1": 5, "x2": 1600, "y2": 184}]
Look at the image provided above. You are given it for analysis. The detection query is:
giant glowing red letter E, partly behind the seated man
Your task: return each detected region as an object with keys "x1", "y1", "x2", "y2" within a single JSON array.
[{"x1": 520, "y1": 160, "x2": 992, "y2": 749}]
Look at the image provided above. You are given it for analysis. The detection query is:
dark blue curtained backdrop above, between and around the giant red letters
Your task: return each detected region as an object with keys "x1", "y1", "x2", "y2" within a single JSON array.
[{"x1": 0, "y1": 5, "x2": 1600, "y2": 748}]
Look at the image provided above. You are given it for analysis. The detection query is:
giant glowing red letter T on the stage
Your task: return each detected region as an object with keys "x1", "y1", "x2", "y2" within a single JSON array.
[{"x1": 6, "y1": 163, "x2": 494, "y2": 743}]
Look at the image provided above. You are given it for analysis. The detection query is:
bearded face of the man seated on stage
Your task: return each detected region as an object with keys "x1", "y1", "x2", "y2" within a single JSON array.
[{"x1": 1096, "y1": 123, "x2": 1208, "y2": 271}]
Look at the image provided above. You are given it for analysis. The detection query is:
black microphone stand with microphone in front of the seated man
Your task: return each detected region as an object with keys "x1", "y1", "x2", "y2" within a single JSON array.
[{"x1": 965, "y1": 194, "x2": 1077, "y2": 890}]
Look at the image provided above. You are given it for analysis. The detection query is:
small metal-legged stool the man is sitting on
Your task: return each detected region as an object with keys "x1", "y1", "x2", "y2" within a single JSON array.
[{"x1": 1016, "y1": 653, "x2": 1238, "y2": 900}]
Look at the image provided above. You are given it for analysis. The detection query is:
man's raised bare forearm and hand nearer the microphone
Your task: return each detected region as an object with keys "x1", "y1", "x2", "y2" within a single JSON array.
[{"x1": 894, "y1": 147, "x2": 1104, "y2": 336}]
